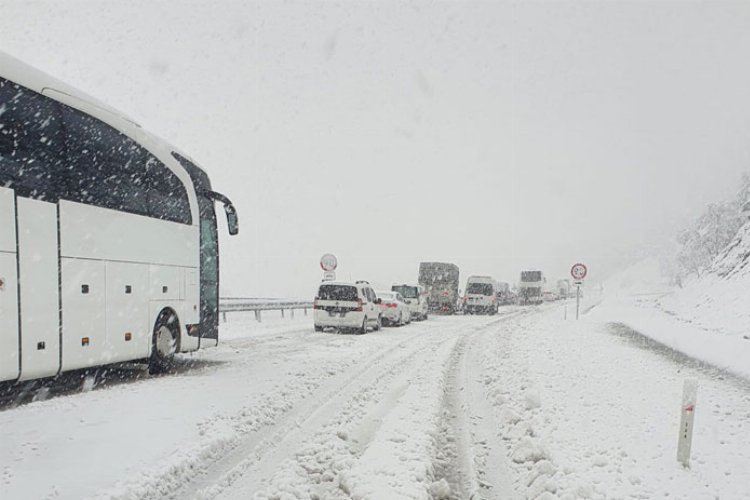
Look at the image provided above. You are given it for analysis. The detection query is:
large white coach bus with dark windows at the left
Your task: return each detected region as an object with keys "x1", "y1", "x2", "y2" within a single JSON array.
[{"x1": 0, "y1": 53, "x2": 238, "y2": 381}]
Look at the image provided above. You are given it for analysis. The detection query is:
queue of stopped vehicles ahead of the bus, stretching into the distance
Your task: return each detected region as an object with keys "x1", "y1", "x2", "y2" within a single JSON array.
[{"x1": 313, "y1": 262, "x2": 571, "y2": 334}]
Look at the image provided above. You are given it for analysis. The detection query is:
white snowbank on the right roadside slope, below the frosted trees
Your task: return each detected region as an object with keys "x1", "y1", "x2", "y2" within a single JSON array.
[{"x1": 591, "y1": 254, "x2": 750, "y2": 378}]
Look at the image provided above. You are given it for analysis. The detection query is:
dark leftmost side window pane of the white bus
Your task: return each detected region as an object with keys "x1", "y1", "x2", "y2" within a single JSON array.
[{"x1": 0, "y1": 78, "x2": 67, "y2": 201}]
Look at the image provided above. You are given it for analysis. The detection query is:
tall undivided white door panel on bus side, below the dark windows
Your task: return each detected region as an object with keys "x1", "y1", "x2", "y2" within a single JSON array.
[{"x1": 17, "y1": 197, "x2": 60, "y2": 380}]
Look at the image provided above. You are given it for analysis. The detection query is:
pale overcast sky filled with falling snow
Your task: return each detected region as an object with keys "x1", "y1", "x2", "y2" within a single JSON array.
[{"x1": 0, "y1": 0, "x2": 750, "y2": 297}]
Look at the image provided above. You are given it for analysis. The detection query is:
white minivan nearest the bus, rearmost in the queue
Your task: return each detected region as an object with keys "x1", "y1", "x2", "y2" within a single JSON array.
[{"x1": 313, "y1": 281, "x2": 383, "y2": 334}]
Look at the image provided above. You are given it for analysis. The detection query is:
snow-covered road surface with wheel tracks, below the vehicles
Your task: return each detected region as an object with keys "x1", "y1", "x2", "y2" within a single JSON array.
[{"x1": 0, "y1": 305, "x2": 750, "y2": 500}]
